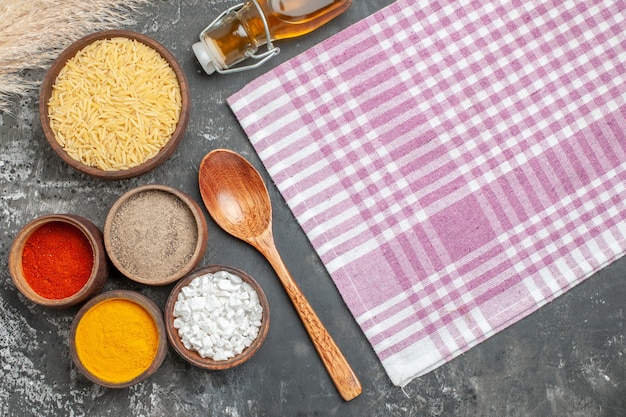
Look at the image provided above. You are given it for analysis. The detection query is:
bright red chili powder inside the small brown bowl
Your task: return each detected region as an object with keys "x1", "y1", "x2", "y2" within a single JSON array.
[{"x1": 22, "y1": 221, "x2": 94, "y2": 300}]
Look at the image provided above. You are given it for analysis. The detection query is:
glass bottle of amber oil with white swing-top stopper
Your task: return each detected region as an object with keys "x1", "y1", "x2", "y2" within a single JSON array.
[{"x1": 193, "y1": 0, "x2": 352, "y2": 74}]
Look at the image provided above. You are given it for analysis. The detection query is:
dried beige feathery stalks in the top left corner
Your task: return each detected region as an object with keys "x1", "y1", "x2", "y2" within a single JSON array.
[{"x1": 0, "y1": 0, "x2": 149, "y2": 112}]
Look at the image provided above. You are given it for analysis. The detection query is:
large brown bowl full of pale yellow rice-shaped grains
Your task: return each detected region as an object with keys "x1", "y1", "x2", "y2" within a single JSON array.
[{"x1": 39, "y1": 30, "x2": 191, "y2": 179}]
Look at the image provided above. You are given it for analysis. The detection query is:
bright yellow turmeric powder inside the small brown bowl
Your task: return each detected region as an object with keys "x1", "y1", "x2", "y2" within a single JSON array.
[{"x1": 75, "y1": 298, "x2": 159, "y2": 383}]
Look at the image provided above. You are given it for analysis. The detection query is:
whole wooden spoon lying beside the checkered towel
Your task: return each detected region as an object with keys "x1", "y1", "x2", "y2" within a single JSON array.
[{"x1": 198, "y1": 149, "x2": 362, "y2": 401}]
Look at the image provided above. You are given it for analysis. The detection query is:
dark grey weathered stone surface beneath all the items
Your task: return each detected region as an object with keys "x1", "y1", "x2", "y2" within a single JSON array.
[{"x1": 0, "y1": 0, "x2": 626, "y2": 417}]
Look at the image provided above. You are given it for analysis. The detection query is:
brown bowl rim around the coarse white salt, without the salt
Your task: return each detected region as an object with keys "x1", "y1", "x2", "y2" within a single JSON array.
[{"x1": 165, "y1": 265, "x2": 270, "y2": 371}]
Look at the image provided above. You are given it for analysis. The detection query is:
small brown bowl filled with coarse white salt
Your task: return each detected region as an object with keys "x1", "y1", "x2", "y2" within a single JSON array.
[{"x1": 165, "y1": 265, "x2": 270, "y2": 370}]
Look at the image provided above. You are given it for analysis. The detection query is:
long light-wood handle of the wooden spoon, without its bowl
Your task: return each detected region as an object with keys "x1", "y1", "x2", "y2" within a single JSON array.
[{"x1": 255, "y1": 231, "x2": 362, "y2": 401}]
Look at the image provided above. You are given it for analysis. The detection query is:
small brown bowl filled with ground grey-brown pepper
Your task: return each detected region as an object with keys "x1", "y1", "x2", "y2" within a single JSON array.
[{"x1": 104, "y1": 184, "x2": 208, "y2": 285}]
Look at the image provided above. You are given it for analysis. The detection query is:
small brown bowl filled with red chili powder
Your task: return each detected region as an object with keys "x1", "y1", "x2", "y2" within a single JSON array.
[{"x1": 9, "y1": 214, "x2": 109, "y2": 308}]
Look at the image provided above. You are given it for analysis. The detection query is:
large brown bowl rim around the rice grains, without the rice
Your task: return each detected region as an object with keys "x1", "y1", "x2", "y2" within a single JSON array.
[{"x1": 39, "y1": 30, "x2": 191, "y2": 179}]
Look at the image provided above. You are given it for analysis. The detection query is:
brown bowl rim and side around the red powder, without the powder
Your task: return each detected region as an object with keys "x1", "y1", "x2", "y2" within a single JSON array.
[{"x1": 9, "y1": 214, "x2": 109, "y2": 308}]
